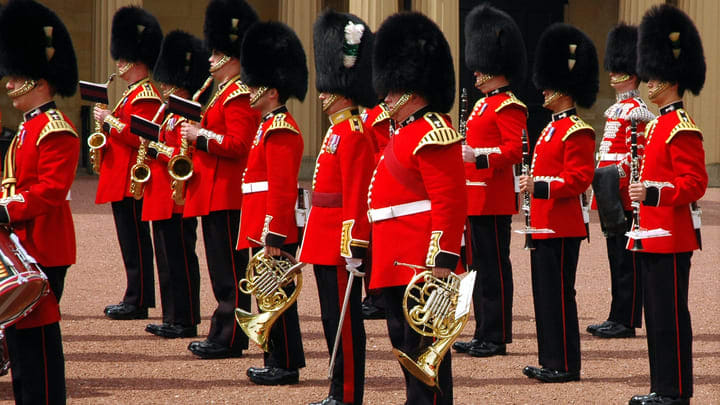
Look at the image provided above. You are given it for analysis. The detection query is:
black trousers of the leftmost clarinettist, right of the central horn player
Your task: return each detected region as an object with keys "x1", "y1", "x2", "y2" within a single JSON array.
[{"x1": 468, "y1": 215, "x2": 513, "y2": 343}]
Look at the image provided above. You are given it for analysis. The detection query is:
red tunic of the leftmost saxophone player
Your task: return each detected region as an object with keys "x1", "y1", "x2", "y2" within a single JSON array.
[{"x1": 95, "y1": 78, "x2": 162, "y2": 204}]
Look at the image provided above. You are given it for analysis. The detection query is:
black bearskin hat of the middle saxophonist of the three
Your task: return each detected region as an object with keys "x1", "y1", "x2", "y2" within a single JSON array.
[{"x1": 153, "y1": 30, "x2": 210, "y2": 103}]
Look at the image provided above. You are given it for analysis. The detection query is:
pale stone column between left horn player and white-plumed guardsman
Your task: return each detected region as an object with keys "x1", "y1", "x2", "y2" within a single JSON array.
[{"x1": 280, "y1": 0, "x2": 324, "y2": 179}]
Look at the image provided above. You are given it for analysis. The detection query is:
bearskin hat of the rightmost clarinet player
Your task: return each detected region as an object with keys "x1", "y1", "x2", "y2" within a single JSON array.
[{"x1": 637, "y1": 4, "x2": 706, "y2": 95}]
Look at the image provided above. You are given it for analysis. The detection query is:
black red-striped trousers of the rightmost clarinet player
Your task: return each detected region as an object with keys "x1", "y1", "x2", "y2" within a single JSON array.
[{"x1": 638, "y1": 252, "x2": 693, "y2": 398}]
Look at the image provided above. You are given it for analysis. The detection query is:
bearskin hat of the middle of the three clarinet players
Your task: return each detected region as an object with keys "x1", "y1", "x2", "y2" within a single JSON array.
[{"x1": 533, "y1": 23, "x2": 599, "y2": 108}]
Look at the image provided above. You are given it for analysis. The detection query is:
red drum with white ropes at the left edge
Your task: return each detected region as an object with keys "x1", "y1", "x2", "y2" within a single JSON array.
[{"x1": 0, "y1": 227, "x2": 49, "y2": 330}]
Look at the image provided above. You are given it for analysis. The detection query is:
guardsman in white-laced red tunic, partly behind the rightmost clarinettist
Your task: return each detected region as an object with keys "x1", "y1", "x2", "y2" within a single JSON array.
[{"x1": 587, "y1": 24, "x2": 655, "y2": 338}]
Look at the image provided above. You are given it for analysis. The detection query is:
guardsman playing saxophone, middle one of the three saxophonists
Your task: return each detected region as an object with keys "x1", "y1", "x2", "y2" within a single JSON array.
[{"x1": 142, "y1": 31, "x2": 211, "y2": 338}]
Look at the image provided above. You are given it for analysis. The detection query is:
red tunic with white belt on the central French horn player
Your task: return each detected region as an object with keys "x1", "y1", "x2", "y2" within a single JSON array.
[{"x1": 368, "y1": 113, "x2": 467, "y2": 288}]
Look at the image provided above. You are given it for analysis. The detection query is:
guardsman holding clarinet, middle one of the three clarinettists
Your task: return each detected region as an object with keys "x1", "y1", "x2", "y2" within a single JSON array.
[{"x1": 520, "y1": 23, "x2": 598, "y2": 383}]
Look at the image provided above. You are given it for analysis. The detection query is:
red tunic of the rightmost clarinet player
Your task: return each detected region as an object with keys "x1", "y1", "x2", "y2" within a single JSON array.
[{"x1": 628, "y1": 108, "x2": 708, "y2": 253}]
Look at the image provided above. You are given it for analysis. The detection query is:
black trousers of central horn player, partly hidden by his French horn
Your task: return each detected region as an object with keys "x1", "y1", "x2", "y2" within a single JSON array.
[{"x1": 381, "y1": 286, "x2": 453, "y2": 405}]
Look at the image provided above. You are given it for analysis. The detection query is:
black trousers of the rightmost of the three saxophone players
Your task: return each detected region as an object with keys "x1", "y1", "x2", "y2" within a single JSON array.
[{"x1": 201, "y1": 210, "x2": 250, "y2": 350}]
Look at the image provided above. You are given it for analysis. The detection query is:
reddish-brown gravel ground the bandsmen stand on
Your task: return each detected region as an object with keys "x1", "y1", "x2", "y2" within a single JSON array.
[{"x1": 0, "y1": 176, "x2": 720, "y2": 404}]
